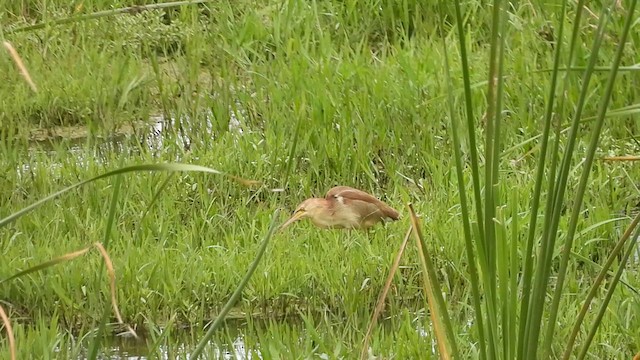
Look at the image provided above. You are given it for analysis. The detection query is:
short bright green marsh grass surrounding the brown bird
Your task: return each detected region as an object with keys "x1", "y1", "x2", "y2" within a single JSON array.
[{"x1": 0, "y1": 0, "x2": 640, "y2": 358}]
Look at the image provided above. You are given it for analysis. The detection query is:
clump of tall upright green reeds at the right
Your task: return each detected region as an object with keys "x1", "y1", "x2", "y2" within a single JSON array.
[{"x1": 440, "y1": 0, "x2": 636, "y2": 359}]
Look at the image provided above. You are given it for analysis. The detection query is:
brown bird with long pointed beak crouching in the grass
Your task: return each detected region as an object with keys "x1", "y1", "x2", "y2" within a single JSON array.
[{"x1": 281, "y1": 186, "x2": 400, "y2": 229}]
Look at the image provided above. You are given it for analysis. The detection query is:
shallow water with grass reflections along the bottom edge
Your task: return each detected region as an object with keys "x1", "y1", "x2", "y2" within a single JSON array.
[{"x1": 75, "y1": 310, "x2": 436, "y2": 360}]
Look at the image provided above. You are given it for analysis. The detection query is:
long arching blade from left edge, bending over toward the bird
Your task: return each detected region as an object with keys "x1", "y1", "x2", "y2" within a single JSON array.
[{"x1": 0, "y1": 163, "x2": 260, "y2": 228}]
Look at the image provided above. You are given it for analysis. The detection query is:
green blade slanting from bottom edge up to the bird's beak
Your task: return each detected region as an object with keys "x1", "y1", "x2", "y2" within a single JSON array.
[{"x1": 189, "y1": 210, "x2": 278, "y2": 359}]
